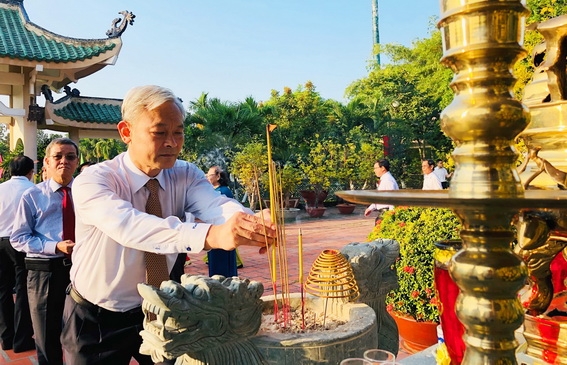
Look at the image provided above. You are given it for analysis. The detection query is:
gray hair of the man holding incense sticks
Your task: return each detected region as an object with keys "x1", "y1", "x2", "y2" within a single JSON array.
[{"x1": 122, "y1": 85, "x2": 186, "y2": 122}]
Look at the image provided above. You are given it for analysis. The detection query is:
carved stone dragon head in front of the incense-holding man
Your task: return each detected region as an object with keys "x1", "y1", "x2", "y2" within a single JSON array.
[{"x1": 138, "y1": 275, "x2": 267, "y2": 365}]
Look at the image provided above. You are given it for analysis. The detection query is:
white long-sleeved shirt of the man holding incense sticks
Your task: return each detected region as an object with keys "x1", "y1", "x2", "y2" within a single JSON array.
[{"x1": 71, "y1": 152, "x2": 252, "y2": 312}]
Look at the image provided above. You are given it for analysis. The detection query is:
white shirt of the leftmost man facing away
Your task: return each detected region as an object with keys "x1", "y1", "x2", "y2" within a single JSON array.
[{"x1": 0, "y1": 176, "x2": 34, "y2": 237}]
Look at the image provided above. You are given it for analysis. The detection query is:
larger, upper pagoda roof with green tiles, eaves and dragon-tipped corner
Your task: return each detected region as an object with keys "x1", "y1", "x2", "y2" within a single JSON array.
[{"x1": 0, "y1": 0, "x2": 135, "y2": 90}]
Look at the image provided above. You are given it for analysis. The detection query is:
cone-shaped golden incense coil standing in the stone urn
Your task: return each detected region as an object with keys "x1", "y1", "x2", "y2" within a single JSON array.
[{"x1": 305, "y1": 250, "x2": 359, "y2": 302}]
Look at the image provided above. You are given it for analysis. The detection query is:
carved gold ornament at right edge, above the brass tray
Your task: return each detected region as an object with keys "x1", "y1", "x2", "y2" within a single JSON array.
[{"x1": 519, "y1": 15, "x2": 567, "y2": 189}]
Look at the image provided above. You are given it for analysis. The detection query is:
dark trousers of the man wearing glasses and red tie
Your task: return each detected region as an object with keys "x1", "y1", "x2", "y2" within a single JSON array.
[{"x1": 28, "y1": 259, "x2": 72, "y2": 365}]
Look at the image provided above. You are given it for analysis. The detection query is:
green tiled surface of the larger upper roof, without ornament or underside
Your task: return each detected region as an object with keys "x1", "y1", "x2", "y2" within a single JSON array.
[{"x1": 0, "y1": 1, "x2": 120, "y2": 63}]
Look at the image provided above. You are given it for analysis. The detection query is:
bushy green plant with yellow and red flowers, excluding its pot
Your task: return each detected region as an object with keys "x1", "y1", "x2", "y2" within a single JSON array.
[{"x1": 369, "y1": 207, "x2": 461, "y2": 322}]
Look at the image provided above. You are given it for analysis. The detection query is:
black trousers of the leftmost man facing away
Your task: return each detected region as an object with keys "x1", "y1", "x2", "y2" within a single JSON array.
[{"x1": 0, "y1": 237, "x2": 35, "y2": 352}]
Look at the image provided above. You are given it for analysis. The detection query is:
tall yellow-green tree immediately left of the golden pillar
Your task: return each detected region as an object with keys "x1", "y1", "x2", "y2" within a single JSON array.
[{"x1": 346, "y1": 30, "x2": 453, "y2": 182}]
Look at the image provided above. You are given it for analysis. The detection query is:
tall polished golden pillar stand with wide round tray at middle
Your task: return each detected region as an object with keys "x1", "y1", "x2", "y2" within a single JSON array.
[{"x1": 337, "y1": 0, "x2": 567, "y2": 365}]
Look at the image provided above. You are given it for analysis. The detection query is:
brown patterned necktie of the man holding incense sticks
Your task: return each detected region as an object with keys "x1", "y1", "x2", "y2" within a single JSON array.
[{"x1": 145, "y1": 179, "x2": 169, "y2": 288}]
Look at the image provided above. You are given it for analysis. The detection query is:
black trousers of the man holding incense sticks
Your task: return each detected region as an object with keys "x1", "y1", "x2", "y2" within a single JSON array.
[{"x1": 61, "y1": 289, "x2": 174, "y2": 365}]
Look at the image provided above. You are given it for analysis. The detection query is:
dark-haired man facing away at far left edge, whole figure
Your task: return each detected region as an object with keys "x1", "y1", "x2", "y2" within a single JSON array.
[{"x1": 0, "y1": 156, "x2": 35, "y2": 352}]
